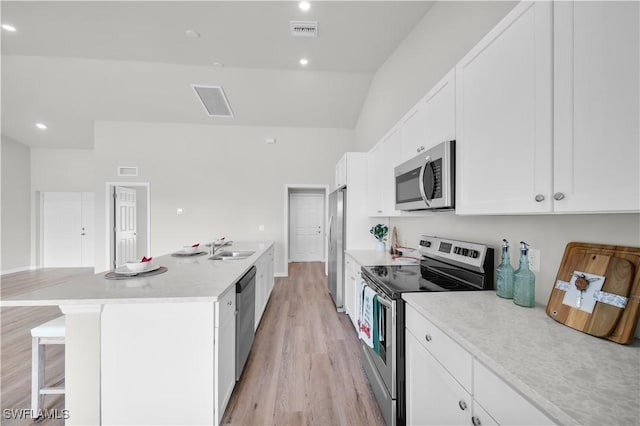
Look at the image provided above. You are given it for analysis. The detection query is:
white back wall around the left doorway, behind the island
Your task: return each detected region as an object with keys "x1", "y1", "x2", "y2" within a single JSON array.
[{"x1": 94, "y1": 122, "x2": 353, "y2": 273}]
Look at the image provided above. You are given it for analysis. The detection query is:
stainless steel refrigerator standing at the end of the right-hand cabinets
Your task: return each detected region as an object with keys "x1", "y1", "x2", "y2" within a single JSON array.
[{"x1": 327, "y1": 187, "x2": 347, "y2": 311}]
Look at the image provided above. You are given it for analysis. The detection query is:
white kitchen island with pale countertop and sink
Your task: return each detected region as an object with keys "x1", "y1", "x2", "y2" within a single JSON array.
[{"x1": 1, "y1": 242, "x2": 273, "y2": 425}]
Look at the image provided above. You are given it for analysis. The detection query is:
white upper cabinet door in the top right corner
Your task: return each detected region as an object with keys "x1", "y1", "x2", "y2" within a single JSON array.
[{"x1": 554, "y1": 1, "x2": 640, "y2": 212}]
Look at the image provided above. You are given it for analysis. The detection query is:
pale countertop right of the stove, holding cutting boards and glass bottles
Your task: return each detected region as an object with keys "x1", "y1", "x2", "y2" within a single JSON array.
[{"x1": 403, "y1": 291, "x2": 640, "y2": 425}]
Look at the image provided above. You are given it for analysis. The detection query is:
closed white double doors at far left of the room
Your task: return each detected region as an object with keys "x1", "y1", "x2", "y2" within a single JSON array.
[{"x1": 42, "y1": 192, "x2": 95, "y2": 268}]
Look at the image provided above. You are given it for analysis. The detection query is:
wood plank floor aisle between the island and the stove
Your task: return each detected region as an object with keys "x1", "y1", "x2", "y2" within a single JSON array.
[{"x1": 223, "y1": 262, "x2": 384, "y2": 425}]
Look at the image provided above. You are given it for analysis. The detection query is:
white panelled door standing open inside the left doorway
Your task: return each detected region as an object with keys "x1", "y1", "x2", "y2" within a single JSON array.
[{"x1": 113, "y1": 186, "x2": 138, "y2": 266}]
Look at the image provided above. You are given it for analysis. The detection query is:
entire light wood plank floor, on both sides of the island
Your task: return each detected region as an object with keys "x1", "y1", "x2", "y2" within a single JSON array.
[{"x1": 0, "y1": 262, "x2": 384, "y2": 426}]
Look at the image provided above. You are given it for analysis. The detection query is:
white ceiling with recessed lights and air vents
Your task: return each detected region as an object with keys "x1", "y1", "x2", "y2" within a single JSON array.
[{"x1": 0, "y1": 1, "x2": 433, "y2": 148}]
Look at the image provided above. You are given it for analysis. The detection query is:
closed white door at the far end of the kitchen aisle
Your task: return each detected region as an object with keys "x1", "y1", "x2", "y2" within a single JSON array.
[{"x1": 289, "y1": 193, "x2": 324, "y2": 262}]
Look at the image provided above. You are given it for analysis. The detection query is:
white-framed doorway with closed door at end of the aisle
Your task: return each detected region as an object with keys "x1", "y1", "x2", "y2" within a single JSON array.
[{"x1": 284, "y1": 185, "x2": 329, "y2": 275}]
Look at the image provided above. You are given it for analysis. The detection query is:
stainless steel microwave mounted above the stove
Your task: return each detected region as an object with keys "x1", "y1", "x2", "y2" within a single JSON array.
[{"x1": 395, "y1": 141, "x2": 456, "y2": 210}]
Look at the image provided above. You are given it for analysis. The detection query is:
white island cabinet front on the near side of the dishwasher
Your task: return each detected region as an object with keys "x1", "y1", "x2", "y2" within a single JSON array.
[{"x1": 214, "y1": 287, "x2": 236, "y2": 424}]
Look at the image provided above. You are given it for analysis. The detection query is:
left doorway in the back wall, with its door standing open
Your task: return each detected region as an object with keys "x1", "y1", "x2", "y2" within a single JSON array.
[{"x1": 107, "y1": 182, "x2": 151, "y2": 268}]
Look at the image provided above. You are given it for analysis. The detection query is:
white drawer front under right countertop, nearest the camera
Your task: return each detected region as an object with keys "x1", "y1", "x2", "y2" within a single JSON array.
[{"x1": 473, "y1": 360, "x2": 555, "y2": 425}]
